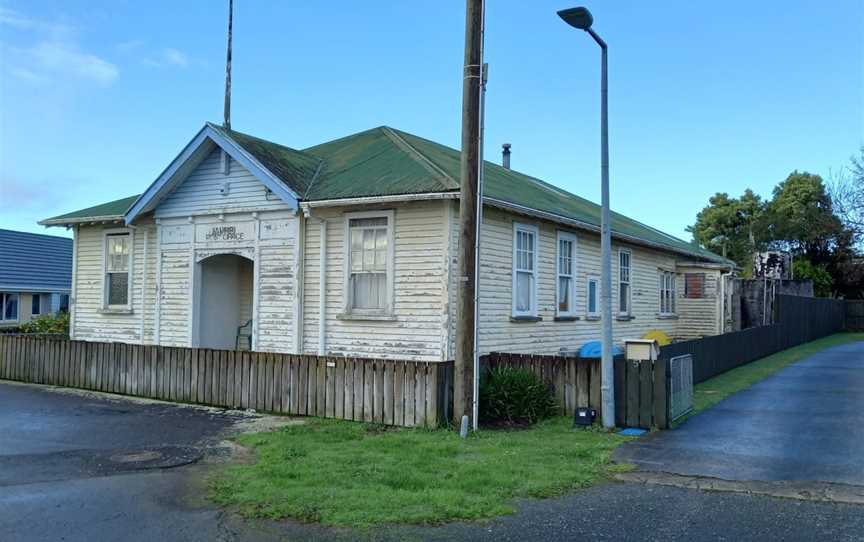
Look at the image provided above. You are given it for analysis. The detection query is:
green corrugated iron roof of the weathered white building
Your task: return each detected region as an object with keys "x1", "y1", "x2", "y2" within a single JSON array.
[{"x1": 43, "y1": 123, "x2": 731, "y2": 264}]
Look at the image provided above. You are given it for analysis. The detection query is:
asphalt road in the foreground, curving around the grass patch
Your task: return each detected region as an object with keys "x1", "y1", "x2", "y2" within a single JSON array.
[{"x1": 0, "y1": 383, "x2": 864, "y2": 542}]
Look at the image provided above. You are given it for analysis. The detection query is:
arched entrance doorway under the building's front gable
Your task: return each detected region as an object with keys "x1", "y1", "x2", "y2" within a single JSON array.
[{"x1": 194, "y1": 254, "x2": 254, "y2": 350}]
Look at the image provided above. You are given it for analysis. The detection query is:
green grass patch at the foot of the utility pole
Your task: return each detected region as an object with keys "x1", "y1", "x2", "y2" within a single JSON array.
[{"x1": 211, "y1": 418, "x2": 626, "y2": 527}]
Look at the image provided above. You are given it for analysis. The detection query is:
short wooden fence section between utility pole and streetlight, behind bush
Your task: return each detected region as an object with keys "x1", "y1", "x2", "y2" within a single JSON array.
[{"x1": 480, "y1": 352, "x2": 600, "y2": 416}]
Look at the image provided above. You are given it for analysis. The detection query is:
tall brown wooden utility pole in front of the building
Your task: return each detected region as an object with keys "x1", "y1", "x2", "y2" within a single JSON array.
[{"x1": 453, "y1": 0, "x2": 483, "y2": 424}]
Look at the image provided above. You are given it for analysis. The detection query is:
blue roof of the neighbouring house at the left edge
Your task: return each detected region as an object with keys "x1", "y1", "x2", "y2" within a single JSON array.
[{"x1": 0, "y1": 229, "x2": 72, "y2": 292}]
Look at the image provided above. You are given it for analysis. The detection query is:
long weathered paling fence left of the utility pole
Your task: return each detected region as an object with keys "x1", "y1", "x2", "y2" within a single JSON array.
[{"x1": 0, "y1": 335, "x2": 453, "y2": 427}]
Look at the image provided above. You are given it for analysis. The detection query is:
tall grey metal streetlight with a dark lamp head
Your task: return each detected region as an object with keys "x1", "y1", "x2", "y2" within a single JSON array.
[{"x1": 558, "y1": 7, "x2": 615, "y2": 428}]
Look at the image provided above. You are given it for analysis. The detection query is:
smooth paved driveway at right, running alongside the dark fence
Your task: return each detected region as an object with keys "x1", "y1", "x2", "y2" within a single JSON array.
[{"x1": 615, "y1": 342, "x2": 864, "y2": 486}]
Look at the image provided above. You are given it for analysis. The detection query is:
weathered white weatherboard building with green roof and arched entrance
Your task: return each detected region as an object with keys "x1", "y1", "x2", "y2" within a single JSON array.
[{"x1": 40, "y1": 123, "x2": 734, "y2": 361}]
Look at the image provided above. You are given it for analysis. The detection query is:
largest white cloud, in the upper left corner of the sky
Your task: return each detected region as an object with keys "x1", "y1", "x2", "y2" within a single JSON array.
[{"x1": 0, "y1": 8, "x2": 119, "y2": 84}]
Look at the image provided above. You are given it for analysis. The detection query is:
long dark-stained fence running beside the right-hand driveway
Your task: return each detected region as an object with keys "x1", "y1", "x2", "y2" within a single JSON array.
[{"x1": 660, "y1": 295, "x2": 845, "y2": 384}]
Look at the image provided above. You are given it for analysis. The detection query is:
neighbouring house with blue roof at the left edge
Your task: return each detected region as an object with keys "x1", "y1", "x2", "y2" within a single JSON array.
[{"x1": 0, "y1": 229, "x2": 73, "y2": 328}]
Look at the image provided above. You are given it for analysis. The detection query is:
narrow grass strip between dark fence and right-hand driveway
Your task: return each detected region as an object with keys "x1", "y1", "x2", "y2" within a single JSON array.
[{"x1": 678, "y1": 333, "x2": 864, "y2": 423}]
